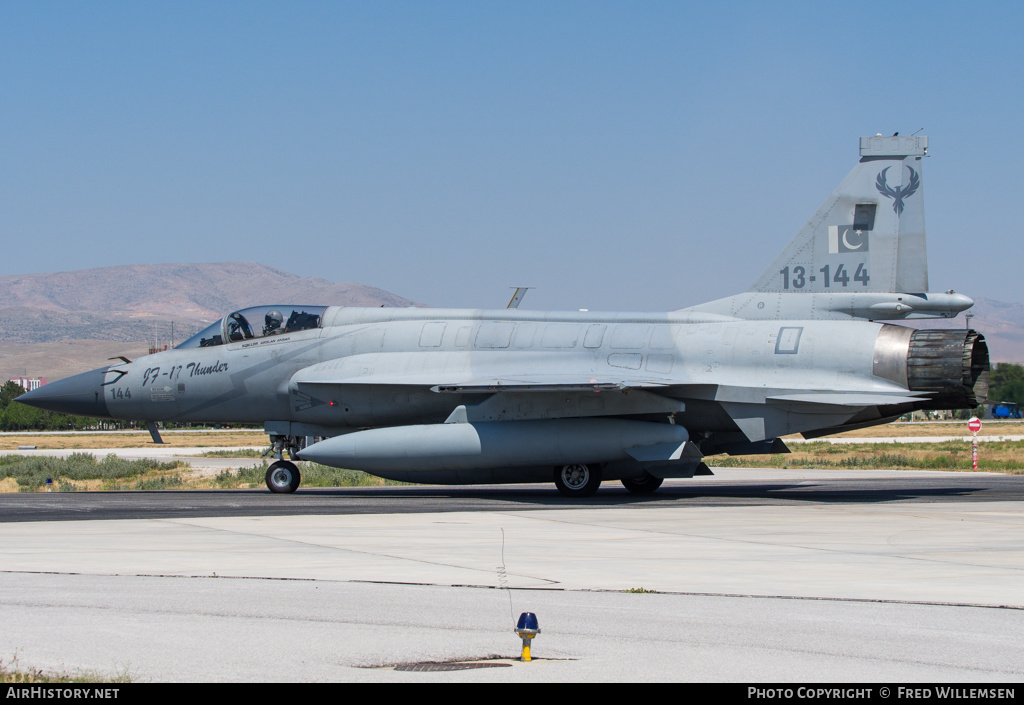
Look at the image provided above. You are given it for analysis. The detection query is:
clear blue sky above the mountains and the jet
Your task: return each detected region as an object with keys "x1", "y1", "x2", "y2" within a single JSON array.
[{"x1": 0, "y1": 0, "x2": 1024, "y2": 310}]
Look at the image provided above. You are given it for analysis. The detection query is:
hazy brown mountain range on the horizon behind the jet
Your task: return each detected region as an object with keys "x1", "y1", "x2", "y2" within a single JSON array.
[{"x1": 0, "y1": 262, "x2": 1024, "y2": 380}]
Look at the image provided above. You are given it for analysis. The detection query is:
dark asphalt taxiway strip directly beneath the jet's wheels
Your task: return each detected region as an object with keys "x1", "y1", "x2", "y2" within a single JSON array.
[{"x1": 0, "y1": 465, "x2": 1024, "y2": 523}]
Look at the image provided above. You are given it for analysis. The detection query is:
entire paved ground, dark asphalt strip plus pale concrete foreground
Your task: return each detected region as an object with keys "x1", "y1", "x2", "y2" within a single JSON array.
[{"x1": 0, "y1": 469, "x2": 1024, "y2": 683}]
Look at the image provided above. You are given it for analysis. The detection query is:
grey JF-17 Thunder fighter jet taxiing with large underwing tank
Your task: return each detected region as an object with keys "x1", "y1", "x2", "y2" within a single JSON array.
[{"x1": 18, "y1": 135, "x2": 989, "y2": 498}]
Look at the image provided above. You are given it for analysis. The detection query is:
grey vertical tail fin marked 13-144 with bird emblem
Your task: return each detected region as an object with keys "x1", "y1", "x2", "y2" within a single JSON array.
[{"x1": 750, "y1": 135, "x2": 928, "y2": 294}]
